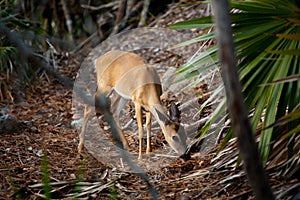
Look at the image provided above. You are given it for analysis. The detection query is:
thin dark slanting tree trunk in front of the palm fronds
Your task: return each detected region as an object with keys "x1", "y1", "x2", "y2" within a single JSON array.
[{"x1": 212, "y1": 0, "x2": 274, "y2": 200}]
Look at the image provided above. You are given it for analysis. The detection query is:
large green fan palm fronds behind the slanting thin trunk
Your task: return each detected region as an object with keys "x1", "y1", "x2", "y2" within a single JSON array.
[{"x1": 171, "y1": 0, "x2": 300, "y2": 163}]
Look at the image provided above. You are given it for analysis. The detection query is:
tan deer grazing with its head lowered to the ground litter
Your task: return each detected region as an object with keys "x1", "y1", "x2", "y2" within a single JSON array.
[{"x1": 78, "y1": 50, "x2": 187, "y2": 159}]
